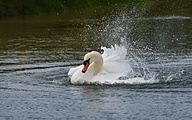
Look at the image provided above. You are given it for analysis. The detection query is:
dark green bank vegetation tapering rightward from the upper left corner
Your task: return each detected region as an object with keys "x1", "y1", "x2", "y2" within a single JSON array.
[{"x1": 0, "y1": 0, "x2": 150, "y2": 18}]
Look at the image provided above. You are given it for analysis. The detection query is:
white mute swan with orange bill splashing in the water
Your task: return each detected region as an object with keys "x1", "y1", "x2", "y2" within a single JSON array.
[{"x1": 68, "y1": 45, "x2": 133, "y2": 84}]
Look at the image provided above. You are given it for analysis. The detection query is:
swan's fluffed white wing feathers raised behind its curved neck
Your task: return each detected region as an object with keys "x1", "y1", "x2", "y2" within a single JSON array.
[{"x1": 97, "y1": 45, "x2": 133, "y2": 80}]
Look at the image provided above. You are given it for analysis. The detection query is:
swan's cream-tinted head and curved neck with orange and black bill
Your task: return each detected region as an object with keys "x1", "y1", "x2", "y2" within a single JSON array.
[{"x1": 82, "y1": 51, "x2": 103, "y2": 74}]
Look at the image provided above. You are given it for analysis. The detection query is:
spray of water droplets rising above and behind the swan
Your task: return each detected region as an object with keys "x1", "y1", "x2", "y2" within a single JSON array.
[{"x1": 80, "y1": 8, "x2": 155, "y2": 83}]
